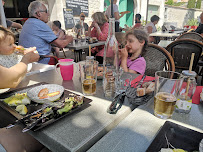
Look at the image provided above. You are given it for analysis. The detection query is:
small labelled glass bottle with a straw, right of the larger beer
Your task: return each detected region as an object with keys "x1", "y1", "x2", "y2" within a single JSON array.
[{"x1": 175, "y1": 70, "x2": 197, "y2": 113}]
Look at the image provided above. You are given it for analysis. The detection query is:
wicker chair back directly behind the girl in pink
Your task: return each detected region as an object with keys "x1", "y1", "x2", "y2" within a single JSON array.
[{"x1": 143, "y1": 43, "x2": 175, "y2": 76}]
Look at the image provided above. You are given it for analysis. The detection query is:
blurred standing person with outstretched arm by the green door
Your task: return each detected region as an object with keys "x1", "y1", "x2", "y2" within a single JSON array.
[{"x1": 105, "y1": 0, "x2": 130, "y2": 32}]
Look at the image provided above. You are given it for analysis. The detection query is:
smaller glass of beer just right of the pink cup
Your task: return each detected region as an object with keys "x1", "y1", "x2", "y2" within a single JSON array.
[{"x1": 79, "y1": 61, "x2": 98, "y2": 95}]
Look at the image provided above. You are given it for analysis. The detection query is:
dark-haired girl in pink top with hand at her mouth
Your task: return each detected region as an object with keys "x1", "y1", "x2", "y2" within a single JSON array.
[{"x1": 119, "y1": 29, "x2": 148, "y2": 74}]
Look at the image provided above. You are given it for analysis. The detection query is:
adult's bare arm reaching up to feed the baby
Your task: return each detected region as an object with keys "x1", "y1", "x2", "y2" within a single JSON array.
[{"x1": 0, "y1": 48, "x2": 39, "y2": 89}]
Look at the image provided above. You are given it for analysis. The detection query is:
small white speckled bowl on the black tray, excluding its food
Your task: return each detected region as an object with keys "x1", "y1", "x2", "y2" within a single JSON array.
[{"x1": 27, "y1": 84, "x2": 64, "y2": 103}]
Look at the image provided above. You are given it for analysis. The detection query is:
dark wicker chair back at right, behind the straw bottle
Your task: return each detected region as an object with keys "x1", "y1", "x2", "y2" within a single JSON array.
[{"x1": 166, "y1": 39, "x2": 203, "y2": 72}]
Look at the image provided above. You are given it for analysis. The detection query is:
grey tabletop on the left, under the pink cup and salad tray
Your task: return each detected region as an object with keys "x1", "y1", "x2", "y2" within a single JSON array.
[{"x1": 0, "y1": 64, "x2": 135, "y2": 152}]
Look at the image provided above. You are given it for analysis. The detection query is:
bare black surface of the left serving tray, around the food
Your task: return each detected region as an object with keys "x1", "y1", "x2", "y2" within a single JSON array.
[{"x1": 0, "y1": 82, "x2": 92, "y2": 131}]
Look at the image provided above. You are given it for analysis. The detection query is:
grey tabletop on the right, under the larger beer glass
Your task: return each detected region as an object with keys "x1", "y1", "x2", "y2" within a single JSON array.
[{"x1": 88, "y1": 91, "x2": 203, "y2": 152}]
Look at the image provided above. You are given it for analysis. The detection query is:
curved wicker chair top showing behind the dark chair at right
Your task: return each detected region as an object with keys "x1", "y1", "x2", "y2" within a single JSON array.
[{"x1": 177, "y1": 32, "x2": 203, "y2": 42}]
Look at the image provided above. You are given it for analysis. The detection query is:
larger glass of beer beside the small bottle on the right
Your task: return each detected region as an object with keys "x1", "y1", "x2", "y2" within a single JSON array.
[{"x1": 154, "y1": 71, "x2": 182, "y2": 119}]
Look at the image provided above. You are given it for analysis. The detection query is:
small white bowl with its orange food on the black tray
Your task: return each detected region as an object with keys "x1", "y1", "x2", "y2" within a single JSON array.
[{"x1": 27, "y1": 84, "x2": 64, "y2": 103}]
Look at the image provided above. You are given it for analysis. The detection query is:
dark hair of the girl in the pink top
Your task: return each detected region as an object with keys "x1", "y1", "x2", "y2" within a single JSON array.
[{"x1": 125, "y1": 29, "x2": 149, "y2": 56}]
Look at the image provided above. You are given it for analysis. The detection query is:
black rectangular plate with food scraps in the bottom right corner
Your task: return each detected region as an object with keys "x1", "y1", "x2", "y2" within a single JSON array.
[{"x1": 146, "y1": 121, "x2": 203, "y2": 152}]
